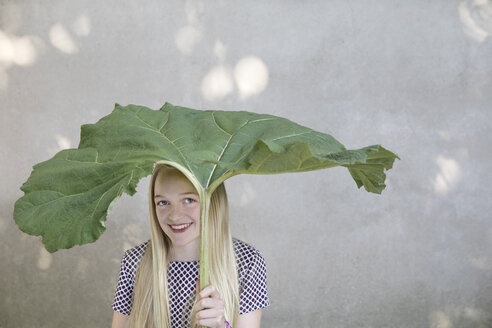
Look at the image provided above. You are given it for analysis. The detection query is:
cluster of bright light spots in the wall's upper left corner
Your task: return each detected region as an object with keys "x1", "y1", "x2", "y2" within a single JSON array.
[{"x1": 0, "y1": 3, "x2": 91, "y2": 90}]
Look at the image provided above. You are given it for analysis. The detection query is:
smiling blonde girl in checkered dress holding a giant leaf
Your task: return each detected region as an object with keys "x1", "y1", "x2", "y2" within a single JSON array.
[{"x1": 112, "y1": 164, "x2": 270, "y2": 328}]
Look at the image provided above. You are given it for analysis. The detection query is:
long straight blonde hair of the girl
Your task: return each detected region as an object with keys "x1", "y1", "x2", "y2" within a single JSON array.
[{"x1": 130, "y1": 164, "x2": 239, "y2": 328}]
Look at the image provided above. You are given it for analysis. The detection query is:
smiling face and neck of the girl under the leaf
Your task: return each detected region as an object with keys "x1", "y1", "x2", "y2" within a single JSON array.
[{"x1": 154, "y1": 168, "x2": 200, "y2": 260}]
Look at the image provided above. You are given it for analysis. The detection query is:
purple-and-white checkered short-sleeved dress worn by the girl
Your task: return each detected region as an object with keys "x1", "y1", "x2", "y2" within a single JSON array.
[{"x1": 113, "y1": 239, "x2": 270, "y2": 328}]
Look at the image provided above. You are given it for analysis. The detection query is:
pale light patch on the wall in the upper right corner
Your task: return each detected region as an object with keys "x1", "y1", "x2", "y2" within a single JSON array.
[{"x1": 458, "y1": 0, "x2": 492, "y2": 42}]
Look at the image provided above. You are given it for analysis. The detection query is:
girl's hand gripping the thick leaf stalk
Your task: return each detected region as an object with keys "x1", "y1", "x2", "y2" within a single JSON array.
[{"x1": 196, "y1": 285, "x2": 225, "y2": 328}]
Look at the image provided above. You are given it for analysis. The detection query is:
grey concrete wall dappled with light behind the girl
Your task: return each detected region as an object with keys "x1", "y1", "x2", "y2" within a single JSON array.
[{"x1": 0, "y1": 0, "x2": 492, "y2": 328}]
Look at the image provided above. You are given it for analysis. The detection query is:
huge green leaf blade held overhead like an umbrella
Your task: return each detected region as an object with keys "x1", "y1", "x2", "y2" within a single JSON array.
[{"x1": 14, "y1": 103, "x2": 397, "y2": 252}]
